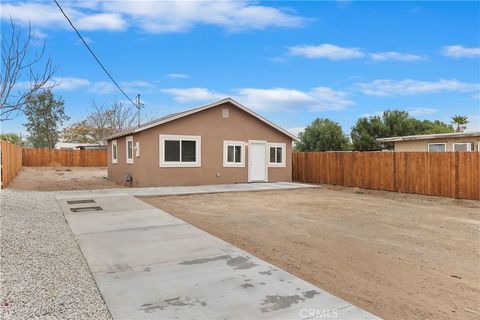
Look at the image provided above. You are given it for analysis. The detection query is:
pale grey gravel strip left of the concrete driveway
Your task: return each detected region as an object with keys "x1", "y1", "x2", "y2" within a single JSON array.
[{"x1": 0, "y1": 189, "x2": 111, "y2": 319}]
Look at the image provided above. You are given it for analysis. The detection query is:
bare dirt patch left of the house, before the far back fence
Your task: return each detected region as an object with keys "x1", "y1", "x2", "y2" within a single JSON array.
[{"x1": 8, "y1": 167, "x2": 121, "y2": 191}]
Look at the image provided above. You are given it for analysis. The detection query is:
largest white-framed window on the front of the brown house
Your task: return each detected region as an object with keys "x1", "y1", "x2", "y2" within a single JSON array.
[{"x1": 159, "y1": 134, "x2": 202, "y2": 167}]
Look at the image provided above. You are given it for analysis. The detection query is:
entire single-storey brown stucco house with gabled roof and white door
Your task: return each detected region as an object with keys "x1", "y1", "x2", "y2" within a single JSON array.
[{"x1": 107, "y1": 98, "x2": 296, "y2": 187}]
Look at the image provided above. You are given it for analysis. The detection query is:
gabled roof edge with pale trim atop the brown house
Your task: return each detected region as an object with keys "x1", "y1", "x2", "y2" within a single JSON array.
[{"x1": 107, "y1": 98, "x2": 298, "y2": 141}]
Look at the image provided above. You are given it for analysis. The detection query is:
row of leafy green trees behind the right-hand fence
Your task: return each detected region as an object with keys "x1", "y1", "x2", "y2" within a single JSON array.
[{"x1": 295, "y1": 110, "x2": 468, "y2": 151}]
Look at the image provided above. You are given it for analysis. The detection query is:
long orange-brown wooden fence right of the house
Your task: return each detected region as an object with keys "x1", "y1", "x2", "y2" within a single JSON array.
[{"x1": 292, "y1": 152, "x2": 480, "y2": 200}]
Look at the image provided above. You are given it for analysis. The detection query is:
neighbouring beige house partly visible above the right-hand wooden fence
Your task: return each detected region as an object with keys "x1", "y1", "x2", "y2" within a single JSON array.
[{"x1": 378, "y1": 131, "x2": 480, "y2": 152}]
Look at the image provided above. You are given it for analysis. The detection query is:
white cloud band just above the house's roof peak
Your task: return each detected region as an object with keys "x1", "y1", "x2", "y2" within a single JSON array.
[{"x1": 161, "y1": 87, "x2": 354, "y2": 112}]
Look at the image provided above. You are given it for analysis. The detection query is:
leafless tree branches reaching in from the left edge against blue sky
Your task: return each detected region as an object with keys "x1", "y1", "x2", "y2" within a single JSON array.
[{"x1": 0, "y1": 19, "x2": 58, "y2": 121}]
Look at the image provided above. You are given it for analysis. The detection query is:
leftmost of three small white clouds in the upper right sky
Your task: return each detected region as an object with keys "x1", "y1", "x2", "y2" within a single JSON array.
[{"x1": 289, "y1": 43, "x2": 365, "y2": 60}]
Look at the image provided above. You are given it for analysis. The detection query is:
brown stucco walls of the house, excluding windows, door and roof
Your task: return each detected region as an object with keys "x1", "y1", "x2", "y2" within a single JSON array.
[{"x1": 108, "y1": 103, "x2": 292, "y2": 187}]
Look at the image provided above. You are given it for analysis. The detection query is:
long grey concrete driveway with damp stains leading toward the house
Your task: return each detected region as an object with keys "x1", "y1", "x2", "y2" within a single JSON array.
[{"x1": 57, "y1": 185, "x2": 376, "y2": 319}]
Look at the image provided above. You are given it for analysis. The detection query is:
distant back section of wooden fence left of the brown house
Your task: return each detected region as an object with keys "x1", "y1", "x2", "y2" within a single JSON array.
[{"x1": 22, "y1": 148, "x2": 107, "y2": 167}]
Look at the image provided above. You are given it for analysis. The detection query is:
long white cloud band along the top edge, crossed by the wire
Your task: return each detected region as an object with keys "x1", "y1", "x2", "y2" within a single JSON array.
[{"x1": 1, "y1": 0, "x2": 306, "y2": 33}]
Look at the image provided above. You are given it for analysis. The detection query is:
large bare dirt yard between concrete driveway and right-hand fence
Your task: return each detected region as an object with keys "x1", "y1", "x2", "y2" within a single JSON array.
[{"x1": 142, "y1": 187, "x2": 480, "y2": 319}]
